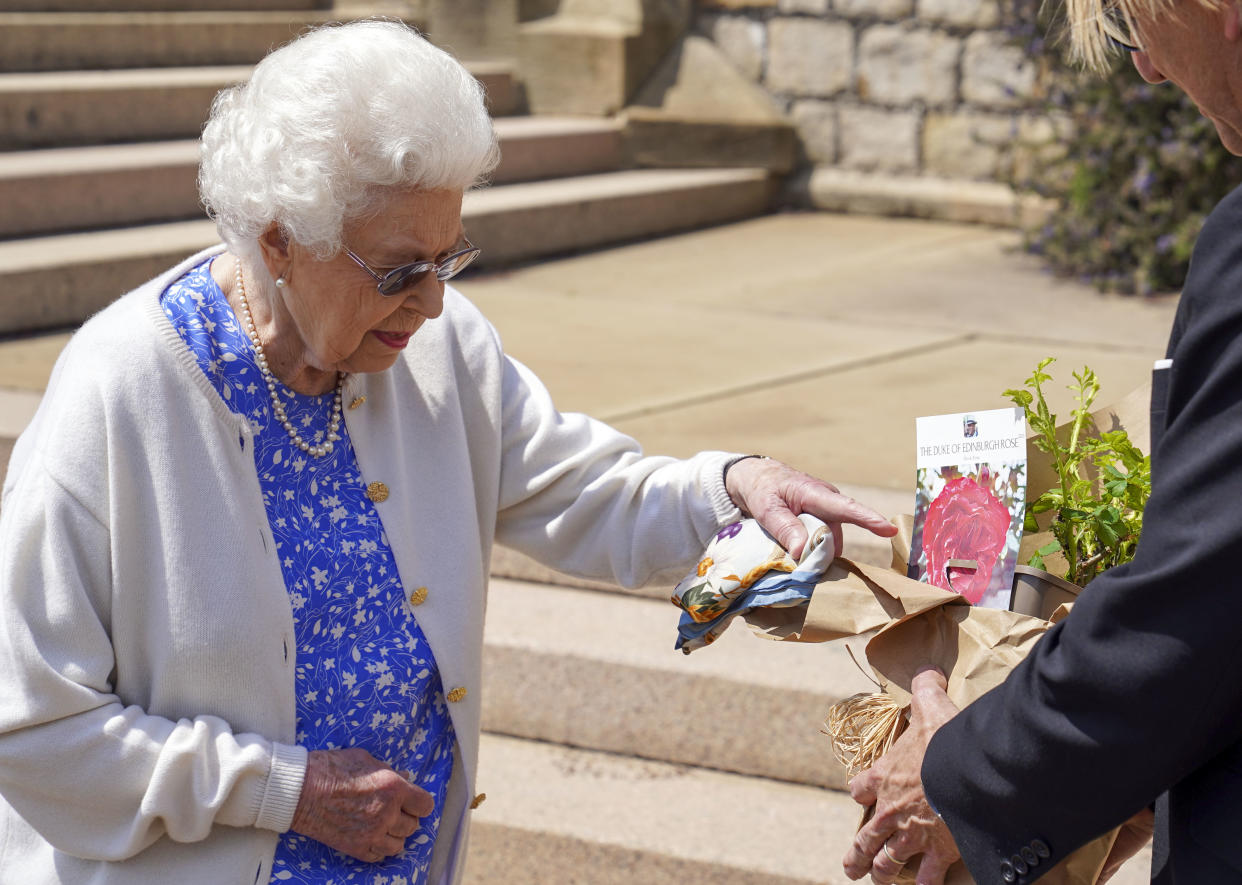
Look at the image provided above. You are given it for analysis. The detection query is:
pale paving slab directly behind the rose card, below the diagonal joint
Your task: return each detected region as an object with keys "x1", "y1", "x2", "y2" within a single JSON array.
[{"x1": 611, "y1": 338, "x2": 1160, "y2": 489}]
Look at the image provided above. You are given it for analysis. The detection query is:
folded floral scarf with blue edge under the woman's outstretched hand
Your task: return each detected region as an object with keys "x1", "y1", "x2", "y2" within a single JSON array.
[{"x1": 673, "y1": 514, "x2": 836, "y2": 654}]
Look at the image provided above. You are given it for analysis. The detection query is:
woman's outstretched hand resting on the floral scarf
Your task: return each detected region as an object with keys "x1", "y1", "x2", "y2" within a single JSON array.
[{"x1": 724, "y1": 458, "x2": 897, "y2": 560}]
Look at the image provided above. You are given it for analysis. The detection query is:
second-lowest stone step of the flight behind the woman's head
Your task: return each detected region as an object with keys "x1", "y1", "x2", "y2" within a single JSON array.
[{"x1": 0, "y1": 118, "x2": 622, "y2": 237}]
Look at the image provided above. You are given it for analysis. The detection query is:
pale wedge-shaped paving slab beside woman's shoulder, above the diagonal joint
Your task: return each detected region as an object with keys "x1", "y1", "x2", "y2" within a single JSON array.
[{"x1": 462, "y1": 284, "x2": 961, "y2": 419}]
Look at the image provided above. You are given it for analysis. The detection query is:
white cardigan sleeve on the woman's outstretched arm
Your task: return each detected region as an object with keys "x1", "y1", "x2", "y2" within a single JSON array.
[{"x1": 497, "y1": 357, "x2": 740, "y2": 586}]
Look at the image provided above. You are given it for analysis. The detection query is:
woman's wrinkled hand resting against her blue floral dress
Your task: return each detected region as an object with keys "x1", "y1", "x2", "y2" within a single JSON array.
[{"x1": 291, "y1": 748, "x2": 435, "y2": 863}]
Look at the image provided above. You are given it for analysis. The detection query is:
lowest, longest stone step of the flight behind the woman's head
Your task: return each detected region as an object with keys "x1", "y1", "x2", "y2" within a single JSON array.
[{"x1": 0, "y1": 169, "x2": 771, "y2": 334}]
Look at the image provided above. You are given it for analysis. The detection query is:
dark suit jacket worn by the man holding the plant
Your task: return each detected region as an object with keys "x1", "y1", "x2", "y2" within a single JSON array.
[{"x1": 923, "y1": 181, "x2": 1242, "y2": 885}]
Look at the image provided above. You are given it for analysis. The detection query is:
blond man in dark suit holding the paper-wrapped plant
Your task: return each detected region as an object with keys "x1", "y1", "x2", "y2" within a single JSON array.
[{"x1": 845, "y1": 0, "x2": 1242, "y2": 885}]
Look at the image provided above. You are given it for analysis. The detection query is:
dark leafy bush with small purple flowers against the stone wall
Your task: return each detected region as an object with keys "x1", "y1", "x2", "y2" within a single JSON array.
[{"x1": 1010, "y1": 0, "x2": 1242, "y2": 294}]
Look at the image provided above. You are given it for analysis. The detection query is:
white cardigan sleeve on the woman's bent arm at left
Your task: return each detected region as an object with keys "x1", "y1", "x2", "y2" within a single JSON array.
[{"x1": 0, "y1": 436, "x2": 306, "y2": 860}]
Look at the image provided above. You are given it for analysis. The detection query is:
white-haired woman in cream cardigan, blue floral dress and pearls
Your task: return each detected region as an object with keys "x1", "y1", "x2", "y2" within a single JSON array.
[{"x1": 0, "y1": 15, "x2": 889, "y2": 885}]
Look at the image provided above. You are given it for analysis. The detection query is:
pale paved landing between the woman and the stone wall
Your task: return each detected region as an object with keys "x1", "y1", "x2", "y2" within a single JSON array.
[{"x1": 461, "y1": 213, "x2": 1176, "y2": 496}]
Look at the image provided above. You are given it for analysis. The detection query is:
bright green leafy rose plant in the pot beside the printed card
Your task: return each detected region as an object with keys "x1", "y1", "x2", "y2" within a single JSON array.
[{"x1": 1005, "y1": 356, "x2": 1151, "y2": 587}]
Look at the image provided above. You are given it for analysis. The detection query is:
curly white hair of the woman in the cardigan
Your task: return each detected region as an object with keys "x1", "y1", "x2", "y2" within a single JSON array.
[{"x1": 199, "y1": 19, "x2": 499, "y2": 258}]
